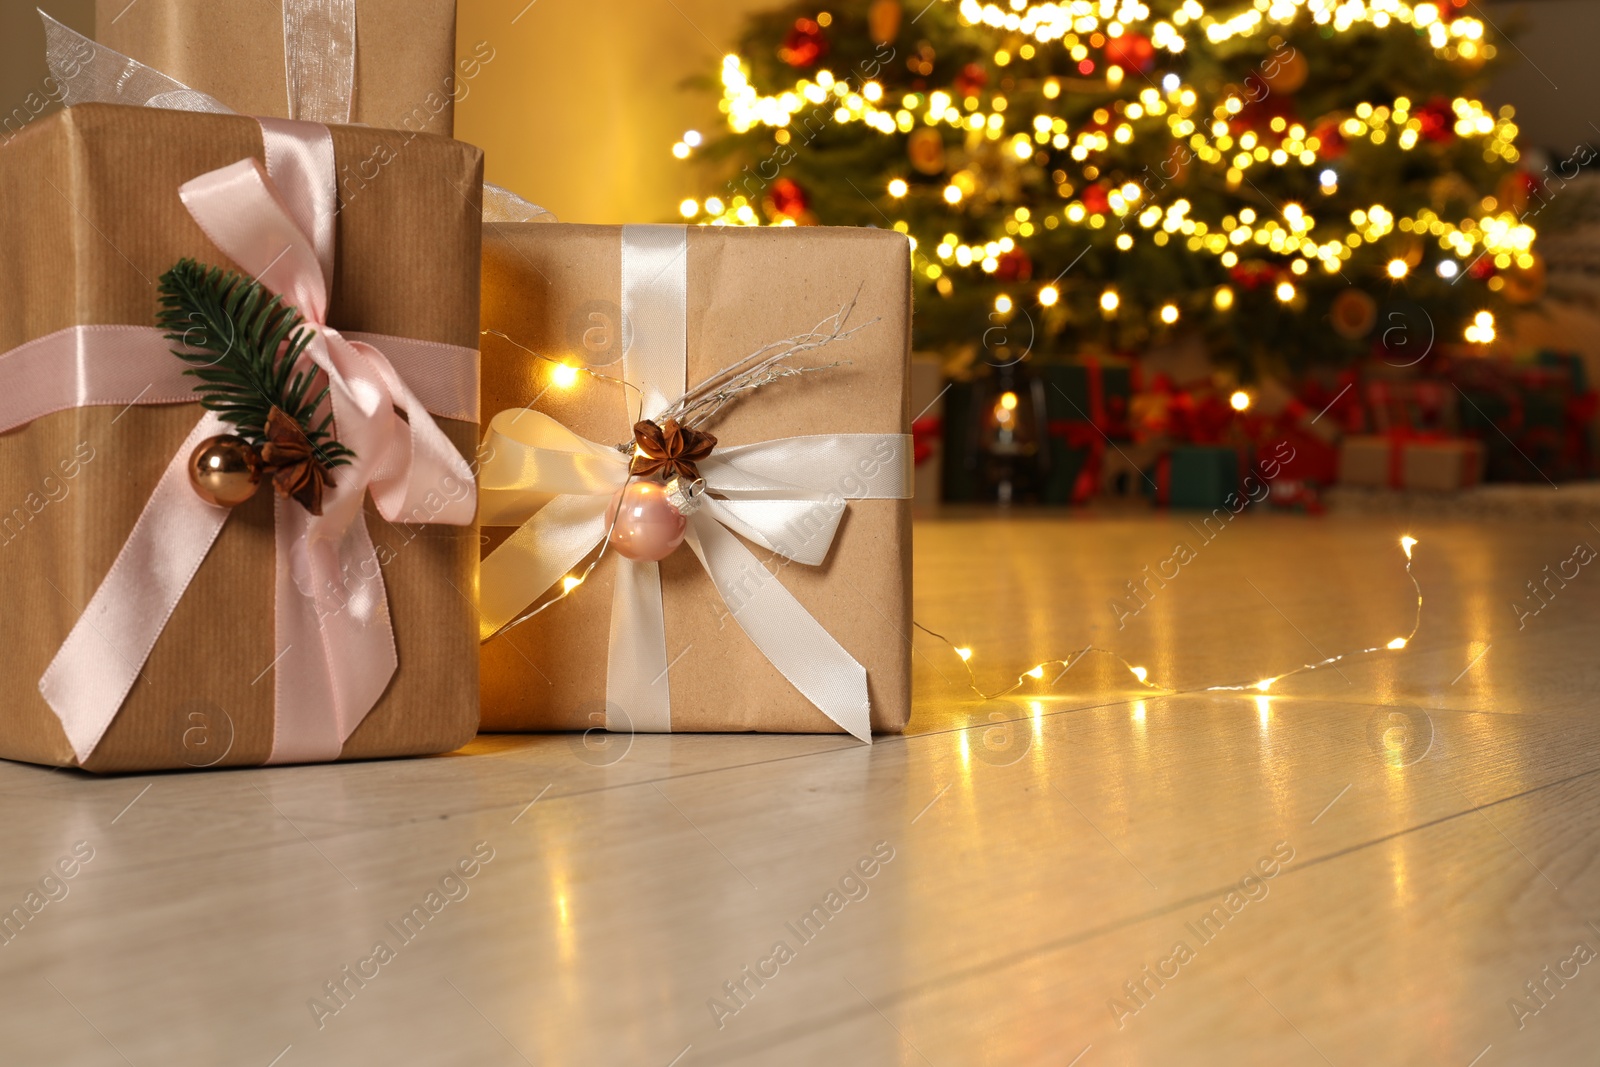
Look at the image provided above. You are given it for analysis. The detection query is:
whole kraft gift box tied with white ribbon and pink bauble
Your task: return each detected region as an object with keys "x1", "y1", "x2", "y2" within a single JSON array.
[{"x1": 480, "y1": 224, "x2": 912, "y2": 737}]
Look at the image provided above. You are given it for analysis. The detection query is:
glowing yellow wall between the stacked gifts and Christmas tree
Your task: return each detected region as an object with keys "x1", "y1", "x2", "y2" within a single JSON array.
[{"x1": 456, "y1": 0, "x2": 774, "y2": 222}]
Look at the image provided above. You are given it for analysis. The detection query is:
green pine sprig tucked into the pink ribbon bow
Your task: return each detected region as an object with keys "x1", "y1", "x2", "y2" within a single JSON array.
[{"x1": 157, "y1": 259, "x2": 355, "y2": 469}]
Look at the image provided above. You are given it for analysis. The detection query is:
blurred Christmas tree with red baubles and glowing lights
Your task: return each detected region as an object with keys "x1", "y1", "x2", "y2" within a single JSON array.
[{"x1": 674, "y1": 0, "x2": 1541, "y2": 374}]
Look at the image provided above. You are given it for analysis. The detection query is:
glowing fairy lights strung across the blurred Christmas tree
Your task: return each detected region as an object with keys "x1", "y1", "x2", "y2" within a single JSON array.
[{"x1": 674, "y1": 0, "x2": 1516, "y2": 344}]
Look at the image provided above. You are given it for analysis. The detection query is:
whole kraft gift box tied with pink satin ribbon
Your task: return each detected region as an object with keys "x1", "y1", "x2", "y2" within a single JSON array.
[{"x1": 0, "y1": 104, "x2": 482, "y2": 771}]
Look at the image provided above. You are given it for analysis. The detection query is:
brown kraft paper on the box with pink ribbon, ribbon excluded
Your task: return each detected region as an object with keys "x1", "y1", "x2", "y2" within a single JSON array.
[{"x1": 0, "y1": 104, "x2": 483, "y2": 771}]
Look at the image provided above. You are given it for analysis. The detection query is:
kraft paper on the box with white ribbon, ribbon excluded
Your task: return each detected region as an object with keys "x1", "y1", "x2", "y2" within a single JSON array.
[{"x1": 482, "y1": 222, "x2": 910, "y2": 733}]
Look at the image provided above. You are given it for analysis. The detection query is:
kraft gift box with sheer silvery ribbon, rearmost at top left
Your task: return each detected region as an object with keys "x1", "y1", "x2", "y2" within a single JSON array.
[{"x1": 94, "y1": 0, "x2": 460, "y2": 136}]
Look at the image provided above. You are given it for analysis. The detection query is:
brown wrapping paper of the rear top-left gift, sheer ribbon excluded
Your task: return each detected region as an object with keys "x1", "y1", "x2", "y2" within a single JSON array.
[{"x1": 94, "y1": 0, "x2": 460, "y2": 138}]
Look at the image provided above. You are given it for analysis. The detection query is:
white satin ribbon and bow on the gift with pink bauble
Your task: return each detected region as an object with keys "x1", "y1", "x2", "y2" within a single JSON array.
[{"x1": 478, "y1": 226, "x2": 912, "y2": 742}]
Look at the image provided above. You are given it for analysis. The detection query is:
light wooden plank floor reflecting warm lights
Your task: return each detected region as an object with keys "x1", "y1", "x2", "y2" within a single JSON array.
[{"x1": 0, "y1": 515, "x2": 1600, "y2": 1067}]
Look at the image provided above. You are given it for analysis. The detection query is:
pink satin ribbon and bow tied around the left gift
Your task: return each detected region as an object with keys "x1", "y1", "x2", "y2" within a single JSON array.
[{"x1": 28, "y1": 120, "x2": 477, "y2": 763}]
